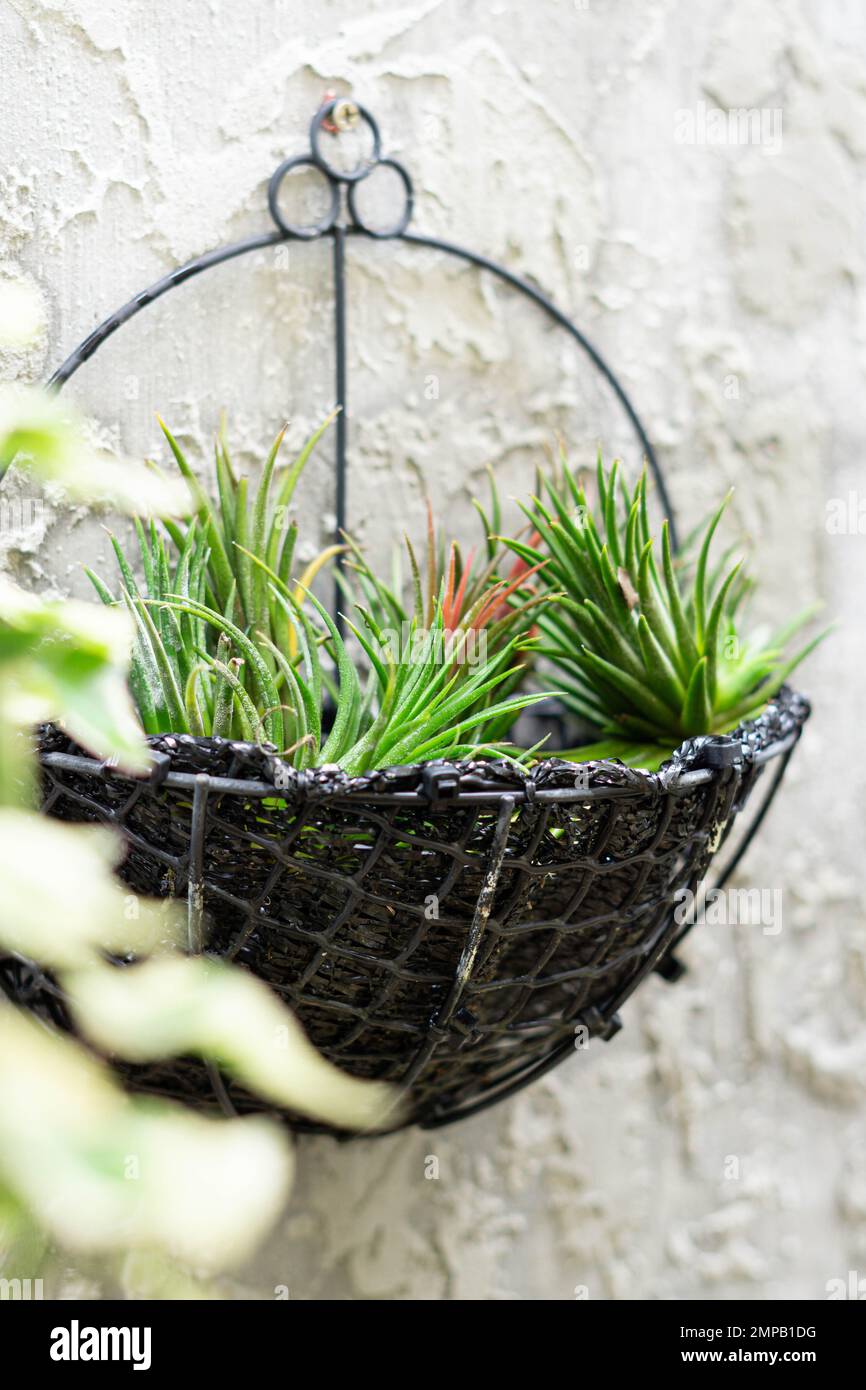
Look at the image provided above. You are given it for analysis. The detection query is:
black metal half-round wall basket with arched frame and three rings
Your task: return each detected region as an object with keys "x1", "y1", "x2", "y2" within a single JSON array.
[{"x1": 0, "y1": 101, "x2": 809, "y2": 1127}]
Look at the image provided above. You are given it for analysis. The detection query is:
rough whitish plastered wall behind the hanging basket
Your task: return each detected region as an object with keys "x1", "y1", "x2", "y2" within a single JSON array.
[{"x1": 0, "y1": 0, "x2": 866, "y2": 1300}]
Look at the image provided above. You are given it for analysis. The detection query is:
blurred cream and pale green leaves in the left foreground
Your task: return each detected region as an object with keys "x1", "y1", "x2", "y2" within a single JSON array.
[{"x1": 0, "y1": 284, "x2": 395, "y2": 1297}]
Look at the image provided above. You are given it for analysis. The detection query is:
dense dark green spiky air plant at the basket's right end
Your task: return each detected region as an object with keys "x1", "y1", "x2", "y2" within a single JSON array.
[{"x1": 506, "y1": 455, "x2": 826, "y2": 769}]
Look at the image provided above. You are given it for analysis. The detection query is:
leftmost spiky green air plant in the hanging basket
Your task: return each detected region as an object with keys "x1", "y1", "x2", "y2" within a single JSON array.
[{"x1": 86, "y1": 416, "x2": 339, "y2": 738}]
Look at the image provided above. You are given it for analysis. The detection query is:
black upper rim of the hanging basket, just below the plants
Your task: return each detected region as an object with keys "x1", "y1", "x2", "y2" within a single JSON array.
[{"x1": 39, "y1": 685, "x2": 812, "y2": 805}]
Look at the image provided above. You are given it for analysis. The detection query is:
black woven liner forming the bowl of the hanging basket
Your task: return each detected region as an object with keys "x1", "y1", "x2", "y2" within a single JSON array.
[{"x1": 0, "y1": 691, "x2": 808, "y2": 1120}]
